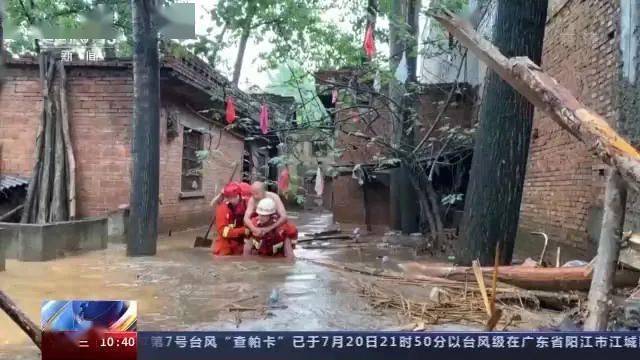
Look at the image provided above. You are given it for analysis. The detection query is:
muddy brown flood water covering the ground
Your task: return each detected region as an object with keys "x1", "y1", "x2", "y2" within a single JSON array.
[{"x1": 0, "y1": 213, "x2": 560, "y2": 359}]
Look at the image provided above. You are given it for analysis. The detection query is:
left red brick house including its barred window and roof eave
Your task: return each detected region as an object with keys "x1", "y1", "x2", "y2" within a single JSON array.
[{"x1": 0, "y1": 51, "x2": 281, "y2": 231}]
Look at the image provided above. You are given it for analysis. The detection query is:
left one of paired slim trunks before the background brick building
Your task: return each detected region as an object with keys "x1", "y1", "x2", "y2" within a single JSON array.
[{"x1": 389, "y1": 0, "x2": 407, "y2": 230}]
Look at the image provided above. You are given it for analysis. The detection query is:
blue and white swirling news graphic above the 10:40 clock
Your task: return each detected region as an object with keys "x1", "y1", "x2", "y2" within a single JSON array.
[{"x1": 41, "y1": 300, "x2": 137, "y2": 331}]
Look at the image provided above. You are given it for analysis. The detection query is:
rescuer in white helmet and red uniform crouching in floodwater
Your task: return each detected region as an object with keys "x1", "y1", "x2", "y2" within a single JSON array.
[{"x1": 245, "y1": 197, "x2": 298, "y2": 259}]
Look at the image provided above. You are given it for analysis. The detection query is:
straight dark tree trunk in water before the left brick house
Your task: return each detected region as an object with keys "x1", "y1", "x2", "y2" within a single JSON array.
[{"x1": 127, "y1": 0, "x2": 160, "y2": 256}]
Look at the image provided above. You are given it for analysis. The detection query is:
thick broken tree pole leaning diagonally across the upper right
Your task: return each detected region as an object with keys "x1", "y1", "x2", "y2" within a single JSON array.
[{"x1": 432, "y1": 12, "x2": 640, "y2": 191}]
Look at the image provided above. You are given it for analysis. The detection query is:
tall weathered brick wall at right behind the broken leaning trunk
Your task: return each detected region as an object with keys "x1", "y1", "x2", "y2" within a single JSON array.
[{"x1": 520, "y1": 0, "x2": 619, "y2": 255}]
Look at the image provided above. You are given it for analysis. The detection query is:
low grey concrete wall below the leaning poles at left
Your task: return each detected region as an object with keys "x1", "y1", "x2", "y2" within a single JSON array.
[{"x1": 0, "y1": 218, "x2": 108, "y2": 261}]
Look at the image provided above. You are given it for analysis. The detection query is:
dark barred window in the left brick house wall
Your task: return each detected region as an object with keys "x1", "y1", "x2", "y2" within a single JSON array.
[{"x1": 181, "y1": 128, "x2": 203, "y2": 192}]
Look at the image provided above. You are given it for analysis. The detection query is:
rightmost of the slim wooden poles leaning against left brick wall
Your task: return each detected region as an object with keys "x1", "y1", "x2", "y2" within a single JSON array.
[{"x1": 58, "y1": 62, "x2": 76, "y2": 220}]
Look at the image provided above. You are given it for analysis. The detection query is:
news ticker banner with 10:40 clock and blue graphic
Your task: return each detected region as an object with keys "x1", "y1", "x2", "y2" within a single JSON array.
[{"x1": 42, "y1": 300, "x2": 640, "y2": 360}]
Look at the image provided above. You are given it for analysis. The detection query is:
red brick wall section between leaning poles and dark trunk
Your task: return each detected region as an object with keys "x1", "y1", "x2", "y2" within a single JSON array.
[{"x1": 67, "y1": 68, "x2": 133, "y2": 216}]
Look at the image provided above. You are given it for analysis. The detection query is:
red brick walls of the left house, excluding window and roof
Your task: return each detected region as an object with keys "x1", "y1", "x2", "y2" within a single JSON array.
[{"x1": 0, "y1": 63, "x2": 244, "y2": 231}]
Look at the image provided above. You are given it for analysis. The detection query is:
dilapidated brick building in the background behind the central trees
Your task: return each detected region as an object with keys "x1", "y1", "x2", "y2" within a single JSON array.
[{"x1": 316, "y1": 69, "x2": 475, "y2": 232}]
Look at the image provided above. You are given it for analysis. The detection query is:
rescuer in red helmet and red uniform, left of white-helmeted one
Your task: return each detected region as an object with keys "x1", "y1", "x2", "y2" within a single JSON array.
[{"x1": 213, "y1": 182, "x2": 250, "y2": 255}]
